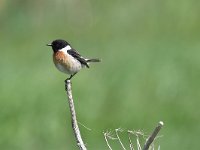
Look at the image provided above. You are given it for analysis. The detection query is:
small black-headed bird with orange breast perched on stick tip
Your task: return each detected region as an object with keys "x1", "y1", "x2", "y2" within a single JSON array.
[{"x1": 47, "y1": 39, "x2": 100, "y2": 80}]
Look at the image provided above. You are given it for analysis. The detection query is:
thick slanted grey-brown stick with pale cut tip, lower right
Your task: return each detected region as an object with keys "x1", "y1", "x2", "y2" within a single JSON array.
[{"x1": 143, "y1": 121, "x2": 164, "y2": 150}]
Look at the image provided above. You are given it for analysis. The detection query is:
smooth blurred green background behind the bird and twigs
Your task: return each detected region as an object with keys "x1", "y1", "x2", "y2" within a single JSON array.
[{"x1": 0, "y1": 0, "x2": 200, "y2": 150}]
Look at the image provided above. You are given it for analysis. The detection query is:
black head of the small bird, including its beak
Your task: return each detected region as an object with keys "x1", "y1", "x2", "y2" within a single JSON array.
[{"x1": 47, "y1": 39, "x2": 69, "y2": 52}]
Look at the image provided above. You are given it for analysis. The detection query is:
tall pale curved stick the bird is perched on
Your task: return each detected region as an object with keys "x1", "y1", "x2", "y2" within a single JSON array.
[{"x1": 65, "y1": 80, "x2": 87, "y2": 150}]
